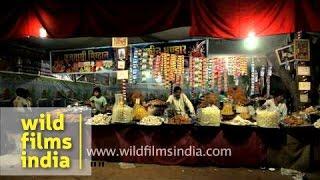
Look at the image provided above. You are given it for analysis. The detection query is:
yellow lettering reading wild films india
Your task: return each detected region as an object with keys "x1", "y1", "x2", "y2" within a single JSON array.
[{"x1": 21, "y1": 113, "x2": 73, "y2": 169}]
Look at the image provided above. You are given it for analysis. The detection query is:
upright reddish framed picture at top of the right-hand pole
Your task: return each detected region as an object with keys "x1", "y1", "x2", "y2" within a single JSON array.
[{"x1": 293, "y1": 39, "x2": 310, "y2": 61}]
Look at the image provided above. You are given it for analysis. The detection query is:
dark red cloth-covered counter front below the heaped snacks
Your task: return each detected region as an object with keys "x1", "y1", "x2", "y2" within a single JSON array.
[{"x1": 86, "y1": 124, "x2": 320, "y2": 170}]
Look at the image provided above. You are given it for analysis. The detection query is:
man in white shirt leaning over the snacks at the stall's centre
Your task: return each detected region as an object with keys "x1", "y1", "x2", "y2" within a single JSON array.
[{"x1": 167, "y1": 86, "x2": 195, "y2": 117}]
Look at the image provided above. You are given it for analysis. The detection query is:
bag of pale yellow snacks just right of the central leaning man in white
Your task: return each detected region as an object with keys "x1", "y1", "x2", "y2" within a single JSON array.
[{"x1": 198, "y1": 106, "x2": 221, "y2": 126}]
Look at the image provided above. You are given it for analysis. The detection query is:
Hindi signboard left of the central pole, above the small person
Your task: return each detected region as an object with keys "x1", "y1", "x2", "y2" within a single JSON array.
[{"x1": 50, "y1": 47, "x2": 115, "y2": 73}]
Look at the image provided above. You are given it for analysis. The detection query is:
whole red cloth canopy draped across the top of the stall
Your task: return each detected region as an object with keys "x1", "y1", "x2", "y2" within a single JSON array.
[{"x1": 0, "y1": 0, "x2": 320, "y2": 39}]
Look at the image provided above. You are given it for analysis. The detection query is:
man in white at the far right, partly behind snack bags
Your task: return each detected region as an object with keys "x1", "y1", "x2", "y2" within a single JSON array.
[{"x1": 263, "y1": 93, "x2": 288, "y2": 118}]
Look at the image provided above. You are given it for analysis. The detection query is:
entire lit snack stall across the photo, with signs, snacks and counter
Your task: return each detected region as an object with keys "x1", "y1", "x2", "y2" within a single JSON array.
[{"x1": 0, "y1": 33, "x2": 320, "y2": 171}]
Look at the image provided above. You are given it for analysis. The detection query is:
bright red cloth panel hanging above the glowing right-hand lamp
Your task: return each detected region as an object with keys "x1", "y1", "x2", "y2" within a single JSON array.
[{"x1": 190, "y1": 0, "x2": 295, "y2": 38}]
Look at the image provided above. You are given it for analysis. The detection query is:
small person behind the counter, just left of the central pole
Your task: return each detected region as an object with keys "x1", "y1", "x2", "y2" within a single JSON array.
[{"x1": 89, "y1": 87, "x2": 107, "y2": 114}]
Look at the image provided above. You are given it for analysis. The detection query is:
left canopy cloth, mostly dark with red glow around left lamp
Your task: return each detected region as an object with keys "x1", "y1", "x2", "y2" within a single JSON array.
[{"x1": 0, "y1": 0, "x2": 190, "y2": 39}]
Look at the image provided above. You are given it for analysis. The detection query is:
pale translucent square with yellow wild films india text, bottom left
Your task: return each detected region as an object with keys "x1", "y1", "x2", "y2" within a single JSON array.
[{"x1": 0, "y1": 107, "x2": 91, "y2": 176}]
